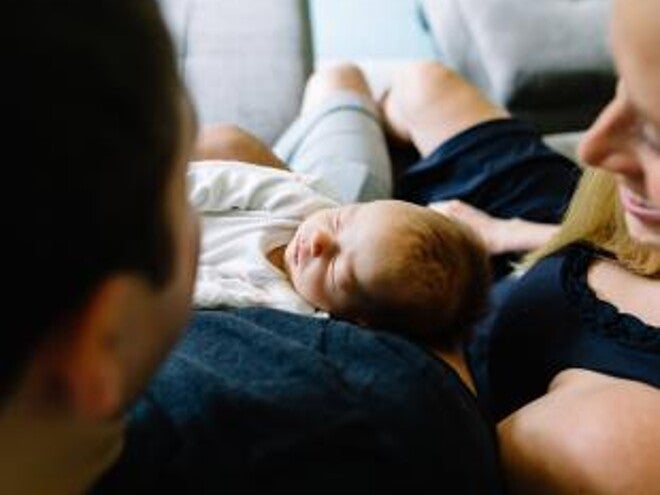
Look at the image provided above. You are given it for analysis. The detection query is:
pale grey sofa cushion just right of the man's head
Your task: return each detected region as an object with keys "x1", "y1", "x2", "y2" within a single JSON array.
[{"x1": 160, "y1": 0, "x2": 311, "y2": 143}]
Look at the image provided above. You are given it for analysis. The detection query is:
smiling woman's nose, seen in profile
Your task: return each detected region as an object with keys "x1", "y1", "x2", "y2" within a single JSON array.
[{"x1": 578, "y1": 91, "x2": 636, "y2": 174}]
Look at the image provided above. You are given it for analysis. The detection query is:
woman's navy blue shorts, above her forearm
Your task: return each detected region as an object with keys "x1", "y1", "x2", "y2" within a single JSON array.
[{"x1": 395, "y1": 119, "x2": 580, "y2": 279}]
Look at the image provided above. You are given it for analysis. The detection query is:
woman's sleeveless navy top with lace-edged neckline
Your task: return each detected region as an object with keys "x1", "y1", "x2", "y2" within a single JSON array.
[{"x1": 471, "y1": 245, "x2": 660, "y2": 420}]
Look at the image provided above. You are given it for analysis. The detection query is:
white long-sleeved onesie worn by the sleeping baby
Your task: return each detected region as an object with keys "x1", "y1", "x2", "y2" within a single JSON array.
[{"x1": 188, "y1": 161, "x2": 339, "y2": 314}]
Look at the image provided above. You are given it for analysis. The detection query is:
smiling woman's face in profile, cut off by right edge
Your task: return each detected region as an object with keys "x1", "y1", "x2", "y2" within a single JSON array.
[{"x1": 579, "y1": 0, "x2": 660, "y2": 248}]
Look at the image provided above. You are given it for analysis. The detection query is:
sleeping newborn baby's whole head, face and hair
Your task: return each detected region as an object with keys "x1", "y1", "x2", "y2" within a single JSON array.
[{"x1": 284, "y1": 200, "x2": 490, "y2": 346}]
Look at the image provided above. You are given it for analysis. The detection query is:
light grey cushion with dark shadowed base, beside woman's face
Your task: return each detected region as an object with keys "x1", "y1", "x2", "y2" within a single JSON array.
[{"x1": 422, "y1": 0, "x2": 615, "y2": 132}]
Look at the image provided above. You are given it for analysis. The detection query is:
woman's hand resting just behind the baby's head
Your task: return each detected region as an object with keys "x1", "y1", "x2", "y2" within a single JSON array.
[{"x1": 428, "y1": 199, "x2": 506, "y2": 254}]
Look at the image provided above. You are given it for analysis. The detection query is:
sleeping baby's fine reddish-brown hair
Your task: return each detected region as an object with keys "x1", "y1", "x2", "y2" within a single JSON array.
[{"x1": 362, "y1": 208, "x2": 491, "y2": 347}]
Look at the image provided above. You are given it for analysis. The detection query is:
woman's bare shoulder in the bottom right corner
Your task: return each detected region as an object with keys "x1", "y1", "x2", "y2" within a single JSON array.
[{"x1": 498, "y1": 370, "x2": 660, "y2": 495}]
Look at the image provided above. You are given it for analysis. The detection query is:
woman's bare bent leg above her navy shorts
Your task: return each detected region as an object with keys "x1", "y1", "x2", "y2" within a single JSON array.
[{"x1": 381, "y1": 62, "x2": 509, "y2": 157}]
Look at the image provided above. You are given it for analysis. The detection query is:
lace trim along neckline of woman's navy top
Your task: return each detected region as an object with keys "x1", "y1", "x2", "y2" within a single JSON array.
[{"x1": 562, "y1": 245, "x2": 660, "y2": 353}]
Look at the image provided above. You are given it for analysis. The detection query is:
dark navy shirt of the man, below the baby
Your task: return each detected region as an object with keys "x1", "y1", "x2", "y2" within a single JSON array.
[{"x1": 95, "y1": 309, "x2": 501, "y2": 494}]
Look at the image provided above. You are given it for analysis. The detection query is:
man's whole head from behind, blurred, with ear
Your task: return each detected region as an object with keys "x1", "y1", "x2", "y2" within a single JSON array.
[{"x1": 0, "y1": 0, "x2": 197, "y2": 418}]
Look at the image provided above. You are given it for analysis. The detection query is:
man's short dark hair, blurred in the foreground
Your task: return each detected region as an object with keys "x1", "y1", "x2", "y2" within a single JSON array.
[{"x1": 0, "y1": 0, "x2": 183, "y2": 396}]
